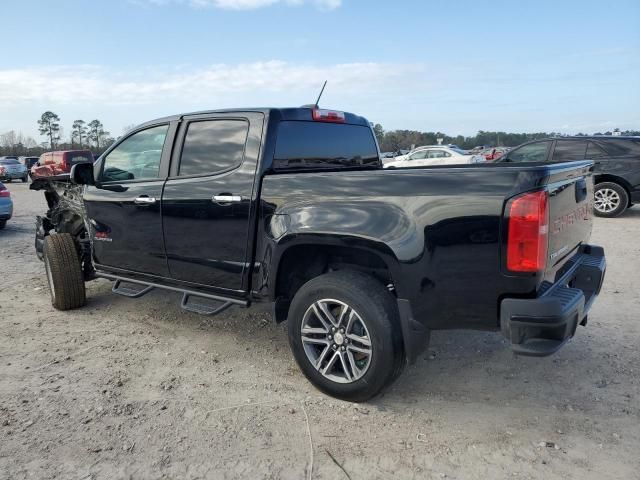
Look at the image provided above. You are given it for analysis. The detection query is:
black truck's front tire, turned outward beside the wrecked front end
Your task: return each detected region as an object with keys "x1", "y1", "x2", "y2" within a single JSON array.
[{"x1": 44, "y1": 233, "x2": 87, "y2": 310}]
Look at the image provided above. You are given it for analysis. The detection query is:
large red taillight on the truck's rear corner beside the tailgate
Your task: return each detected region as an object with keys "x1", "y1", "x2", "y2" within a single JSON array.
[{"x1": 507, "y1": 191, "x2": 549, "y2": 272}]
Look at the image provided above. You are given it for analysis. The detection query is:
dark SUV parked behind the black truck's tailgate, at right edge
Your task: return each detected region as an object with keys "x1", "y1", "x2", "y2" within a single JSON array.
[{"x1": 497, "y1": 136, "x2": 640, "y2": 217}]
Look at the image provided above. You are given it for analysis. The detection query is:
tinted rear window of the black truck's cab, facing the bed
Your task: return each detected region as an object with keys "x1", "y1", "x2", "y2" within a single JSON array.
[{"x1": 273, "y1": 121, "x2": 380, "y2": 170}]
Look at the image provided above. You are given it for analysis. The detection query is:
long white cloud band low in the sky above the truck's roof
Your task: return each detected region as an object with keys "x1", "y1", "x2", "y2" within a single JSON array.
[{"x1": 0, "y1": 61, "x2": 421, "y2": 110}]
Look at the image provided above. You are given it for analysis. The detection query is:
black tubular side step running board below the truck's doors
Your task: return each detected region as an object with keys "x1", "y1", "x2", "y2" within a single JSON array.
[{"x1": 96, "y1": 272, "x2": 249, "y2": 315}]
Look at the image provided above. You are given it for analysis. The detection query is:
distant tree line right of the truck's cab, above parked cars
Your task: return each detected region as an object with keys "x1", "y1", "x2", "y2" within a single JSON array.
[{"x1": 373, "y1": 123, "x2": 640, "y2": 152}]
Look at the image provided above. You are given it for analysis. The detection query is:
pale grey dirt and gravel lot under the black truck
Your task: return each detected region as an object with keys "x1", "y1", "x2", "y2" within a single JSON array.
[{"x1": 0, "y1": 183, "x2": 640, "y2": 480}]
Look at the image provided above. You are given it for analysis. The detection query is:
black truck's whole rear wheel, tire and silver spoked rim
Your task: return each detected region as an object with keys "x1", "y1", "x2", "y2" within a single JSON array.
[{"x1": 288, "y1": 271, "x2": 404, "y2": 401}]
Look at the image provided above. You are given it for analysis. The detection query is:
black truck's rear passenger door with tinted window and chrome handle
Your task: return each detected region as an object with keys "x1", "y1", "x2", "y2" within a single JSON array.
[{"x1": 162, "y1": 112, "x2": 264, "y2": 293}]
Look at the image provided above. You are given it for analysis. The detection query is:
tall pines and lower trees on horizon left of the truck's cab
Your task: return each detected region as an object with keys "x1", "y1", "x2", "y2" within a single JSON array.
[{"x1": 0, "y1": 111, "x2": 115, "y2": 156}]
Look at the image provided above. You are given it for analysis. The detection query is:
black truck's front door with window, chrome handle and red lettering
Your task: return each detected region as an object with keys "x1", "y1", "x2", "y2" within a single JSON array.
[{"x1": 84, "y1": 123, "x2": 175, "y2": 277}]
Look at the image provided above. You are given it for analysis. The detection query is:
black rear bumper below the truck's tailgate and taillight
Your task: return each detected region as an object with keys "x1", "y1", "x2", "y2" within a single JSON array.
[{"x1": 500, "y1": 245, "x2": 606, "y2": 356}]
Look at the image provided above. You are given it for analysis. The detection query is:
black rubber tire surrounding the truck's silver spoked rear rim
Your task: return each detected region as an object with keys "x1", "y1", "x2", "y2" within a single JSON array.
[{"x1": 288, "y1": 270, "x2": 405, "y2": 402}]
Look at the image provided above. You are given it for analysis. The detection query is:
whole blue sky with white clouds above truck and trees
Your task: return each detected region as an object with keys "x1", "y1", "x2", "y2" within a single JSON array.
[{"x1": 0, "y1": 0, "x2": 640, "y2": 142}]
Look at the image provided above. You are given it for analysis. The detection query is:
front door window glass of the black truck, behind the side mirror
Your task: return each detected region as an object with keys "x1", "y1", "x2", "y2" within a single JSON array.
[{"x1": 100, "y1": 125, "x2": 169, "y2": 182}]
